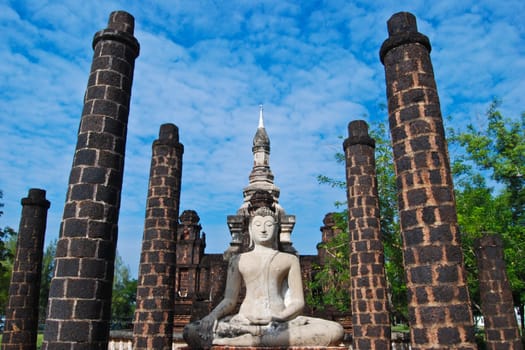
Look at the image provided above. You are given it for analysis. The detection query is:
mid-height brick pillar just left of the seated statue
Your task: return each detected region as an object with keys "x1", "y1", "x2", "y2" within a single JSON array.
[{"x1": 133, "y1": 124, "x2": 184, "y2": 350}]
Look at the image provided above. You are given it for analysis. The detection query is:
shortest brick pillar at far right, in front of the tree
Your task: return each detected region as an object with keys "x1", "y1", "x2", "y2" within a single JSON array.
[{"x1": 474, "y1": 235, "x2": 523, "y2": 350}]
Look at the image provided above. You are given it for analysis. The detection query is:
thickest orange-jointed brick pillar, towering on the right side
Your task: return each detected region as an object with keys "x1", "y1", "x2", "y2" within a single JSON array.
[{"x1": 380, "y1": 12, "x2": 476, "y2": 350}]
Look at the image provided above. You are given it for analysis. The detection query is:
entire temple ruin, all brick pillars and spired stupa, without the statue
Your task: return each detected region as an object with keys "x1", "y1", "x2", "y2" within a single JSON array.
[{"x1": 2, "y1": 7, "x2": 522, "y2": 350}]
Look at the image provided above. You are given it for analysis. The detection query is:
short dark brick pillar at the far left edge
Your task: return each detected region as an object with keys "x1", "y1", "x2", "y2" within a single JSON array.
[{"x1": 2, "y1": 188, "x2": 50, "y2": 350}]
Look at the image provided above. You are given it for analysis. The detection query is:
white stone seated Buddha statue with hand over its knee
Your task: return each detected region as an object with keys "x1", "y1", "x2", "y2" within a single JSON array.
[{"x1": 184, "y1": 191, "x2": 344, "y2": 349}]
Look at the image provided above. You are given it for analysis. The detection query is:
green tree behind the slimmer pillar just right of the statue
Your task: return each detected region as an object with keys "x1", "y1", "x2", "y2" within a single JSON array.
[{"x1": 307, "y1": 123, "x2": 407, "y2": 322}]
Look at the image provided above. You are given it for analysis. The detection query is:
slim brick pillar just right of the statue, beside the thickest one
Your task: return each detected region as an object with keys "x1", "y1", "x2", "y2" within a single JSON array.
[{"x1": 343, "y1": 120, "x2": 391, "y2": 350}]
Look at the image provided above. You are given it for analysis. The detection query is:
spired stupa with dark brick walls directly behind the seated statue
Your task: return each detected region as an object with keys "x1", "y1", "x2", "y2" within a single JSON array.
[{"x1": 174, "y1": 109, "x2": 351, "y2": 340}]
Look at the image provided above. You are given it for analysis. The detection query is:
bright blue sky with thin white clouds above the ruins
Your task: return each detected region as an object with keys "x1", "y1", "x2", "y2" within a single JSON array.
[{"x1": 0, "y1": 0, "x2": 525, "y2": 273}]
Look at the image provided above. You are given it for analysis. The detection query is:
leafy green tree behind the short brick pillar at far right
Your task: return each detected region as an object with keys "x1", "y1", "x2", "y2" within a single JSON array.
[{"x1": 449, "y1": 101, "x2": 525, "y2": 327}]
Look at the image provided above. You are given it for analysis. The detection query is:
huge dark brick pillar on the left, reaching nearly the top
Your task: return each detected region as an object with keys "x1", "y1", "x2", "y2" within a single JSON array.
[{"x1": 43, "y1": 12, "x2": 139, "y2": 350}]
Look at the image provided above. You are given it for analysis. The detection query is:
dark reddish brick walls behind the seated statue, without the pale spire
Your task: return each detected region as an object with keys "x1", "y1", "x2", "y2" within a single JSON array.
[{"x1": 174, "y1": 210, "x2": 352, "y2": 335}]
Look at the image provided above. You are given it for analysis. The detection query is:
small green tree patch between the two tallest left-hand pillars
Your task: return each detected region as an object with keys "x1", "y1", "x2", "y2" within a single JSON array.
[{"x1": 111, "y1": 252, "x2": 137, "y2": 329}]
